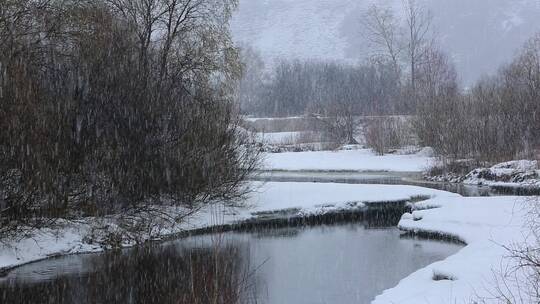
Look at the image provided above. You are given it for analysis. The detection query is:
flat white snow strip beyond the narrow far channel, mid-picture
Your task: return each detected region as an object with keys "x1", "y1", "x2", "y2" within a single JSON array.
[{"x1": 264, "y1": 149, "x2": 434, "y2": 172}]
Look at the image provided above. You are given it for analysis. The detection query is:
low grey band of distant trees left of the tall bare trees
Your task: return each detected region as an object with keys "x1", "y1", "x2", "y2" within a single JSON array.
[{"x1": 240, "y1": 54, "x2": 405, "y2": 117}]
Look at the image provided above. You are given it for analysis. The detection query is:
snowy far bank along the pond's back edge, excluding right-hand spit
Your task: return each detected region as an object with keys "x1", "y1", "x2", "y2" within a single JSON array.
[{"x1": 0, "y1": 182, "x2": 458, "y2": 269}]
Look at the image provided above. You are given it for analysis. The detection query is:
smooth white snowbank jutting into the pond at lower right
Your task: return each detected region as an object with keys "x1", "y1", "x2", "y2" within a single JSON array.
[{"x1": 373, "y1": 197, "x2": 530, "y2": 304}]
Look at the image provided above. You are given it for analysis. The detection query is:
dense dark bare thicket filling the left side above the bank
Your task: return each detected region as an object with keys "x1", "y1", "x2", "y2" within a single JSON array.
[{"x1": 0, "y1": 0, "x2": 256, "y2": 238}]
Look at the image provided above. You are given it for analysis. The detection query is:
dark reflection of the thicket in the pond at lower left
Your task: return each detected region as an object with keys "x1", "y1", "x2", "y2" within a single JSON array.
[{"x1": 0, "y1": 243, "x2": 256, "y2": 304}]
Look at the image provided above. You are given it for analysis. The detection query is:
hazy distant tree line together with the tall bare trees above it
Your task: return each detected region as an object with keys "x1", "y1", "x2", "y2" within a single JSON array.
[{"x1": 239, "y1": 0, "x2": 435, "y2": 116}]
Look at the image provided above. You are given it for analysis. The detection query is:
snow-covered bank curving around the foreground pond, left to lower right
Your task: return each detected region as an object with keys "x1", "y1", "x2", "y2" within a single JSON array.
[{"x1": 0, "y1": 182, "x2": 529, "y2": 304}]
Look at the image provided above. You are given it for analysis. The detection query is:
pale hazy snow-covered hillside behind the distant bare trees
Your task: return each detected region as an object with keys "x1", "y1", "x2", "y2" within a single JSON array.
[{"x1": 232, "y1": 0, "x2": 540, "y2": 84}]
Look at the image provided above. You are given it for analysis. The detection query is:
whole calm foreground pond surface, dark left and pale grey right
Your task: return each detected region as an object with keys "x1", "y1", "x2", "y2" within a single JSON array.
[{"x1": 0, "y1": 223, "x2": 461, "y2": 304}]
